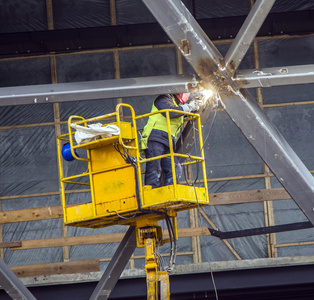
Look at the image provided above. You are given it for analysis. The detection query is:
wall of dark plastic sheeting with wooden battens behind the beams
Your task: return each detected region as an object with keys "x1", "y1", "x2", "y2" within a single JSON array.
[{"x1": 0, "y1": 0, "x2": 314, "y2": 271}]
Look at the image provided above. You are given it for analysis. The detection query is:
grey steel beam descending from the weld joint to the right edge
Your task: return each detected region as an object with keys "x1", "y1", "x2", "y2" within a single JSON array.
[{"x1": 220, "y1": 91, "x2": 314, "y2": 225}]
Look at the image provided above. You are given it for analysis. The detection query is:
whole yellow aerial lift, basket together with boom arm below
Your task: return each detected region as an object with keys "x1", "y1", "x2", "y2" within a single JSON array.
[{"x1": 57, "y1": 104, "x2": 208, "y2": 300}]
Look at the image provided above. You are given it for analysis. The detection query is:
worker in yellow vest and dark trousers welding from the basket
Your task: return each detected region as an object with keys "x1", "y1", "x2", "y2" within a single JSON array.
[{"x1": 141, "y1": 93, "x2": 199, "y2": 188}]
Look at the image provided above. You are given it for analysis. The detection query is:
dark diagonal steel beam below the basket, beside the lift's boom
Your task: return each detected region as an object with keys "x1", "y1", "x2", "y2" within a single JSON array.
[{"x1": 89, "y1": 226, "x2": 136, "y2": 300}]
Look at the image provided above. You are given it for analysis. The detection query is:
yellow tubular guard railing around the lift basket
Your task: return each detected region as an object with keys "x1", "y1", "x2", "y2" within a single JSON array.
[{"x1": 57, "y1": 103, "x2": 207, "y2": 221}]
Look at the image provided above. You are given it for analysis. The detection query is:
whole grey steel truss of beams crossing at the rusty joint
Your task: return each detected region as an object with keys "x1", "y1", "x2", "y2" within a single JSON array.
[{"x1": 0, "y1": 0, "x2": 314, "y2": 224}]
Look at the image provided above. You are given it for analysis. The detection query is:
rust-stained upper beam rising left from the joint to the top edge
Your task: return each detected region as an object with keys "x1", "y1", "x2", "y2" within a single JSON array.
[{"x1": 143, "y1": 0, "x2": 231, "y2": 90}]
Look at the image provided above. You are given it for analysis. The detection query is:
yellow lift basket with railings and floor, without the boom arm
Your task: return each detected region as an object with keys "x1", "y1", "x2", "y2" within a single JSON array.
[{"x1": 57, "y1": 104, "x2": 208, "y2": 232}]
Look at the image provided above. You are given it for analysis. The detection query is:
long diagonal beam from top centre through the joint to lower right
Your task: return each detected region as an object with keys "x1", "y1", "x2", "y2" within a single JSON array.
[{"x1": 143, "y1": 0, "x2": 314, "y2": 225}]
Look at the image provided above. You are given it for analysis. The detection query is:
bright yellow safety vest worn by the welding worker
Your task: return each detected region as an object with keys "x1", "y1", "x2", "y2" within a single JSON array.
[{"x1": 140, "y1": 94, "x2": 183, "y2": 150}]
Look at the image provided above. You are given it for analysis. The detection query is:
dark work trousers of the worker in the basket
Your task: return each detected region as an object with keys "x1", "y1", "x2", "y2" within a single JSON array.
[{"x1": 145, "y1": 141, "x2": 173, "y2": 188}]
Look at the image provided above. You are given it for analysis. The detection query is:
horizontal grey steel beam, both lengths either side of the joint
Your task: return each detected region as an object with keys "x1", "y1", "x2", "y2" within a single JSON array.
[{"x1": 0, "y1": 65, "x2": 314, "y2": 106}]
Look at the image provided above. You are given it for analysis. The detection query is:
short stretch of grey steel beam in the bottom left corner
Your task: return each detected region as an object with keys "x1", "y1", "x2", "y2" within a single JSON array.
[{"x1": 0, "y1": 259, "x2": 36, "y2": 300}]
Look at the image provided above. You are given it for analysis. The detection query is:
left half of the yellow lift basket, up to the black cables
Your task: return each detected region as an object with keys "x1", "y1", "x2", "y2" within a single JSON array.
[{"x1": 58, "y1": 104, "x2": 138, "y2": 227}]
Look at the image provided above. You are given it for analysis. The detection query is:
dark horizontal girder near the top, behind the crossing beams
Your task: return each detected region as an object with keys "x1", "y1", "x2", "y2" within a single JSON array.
[{"x1": 0, "y1": 7, "x2": 314, "y2": 57}]
